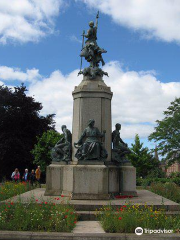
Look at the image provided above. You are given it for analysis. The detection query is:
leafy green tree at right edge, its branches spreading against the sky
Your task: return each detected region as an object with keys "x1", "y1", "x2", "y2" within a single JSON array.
[{"x1": 149, "y1": 98, "x2": 180, "y2": 160}]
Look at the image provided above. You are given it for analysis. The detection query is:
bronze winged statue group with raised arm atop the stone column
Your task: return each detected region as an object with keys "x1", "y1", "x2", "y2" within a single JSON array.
[{"x1": 79, "y1": 12, "x2": 108, "y2": 79}]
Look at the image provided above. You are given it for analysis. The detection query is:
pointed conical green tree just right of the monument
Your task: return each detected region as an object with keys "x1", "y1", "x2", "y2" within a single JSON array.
[{"x1": 128, "y1": 134, "x2": 159, "y2": 178}]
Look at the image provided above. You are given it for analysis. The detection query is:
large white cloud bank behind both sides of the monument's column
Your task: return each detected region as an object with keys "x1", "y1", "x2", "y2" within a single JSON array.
[{"x1": 0, "y1": 62, "x2": 180, "y2": 138}]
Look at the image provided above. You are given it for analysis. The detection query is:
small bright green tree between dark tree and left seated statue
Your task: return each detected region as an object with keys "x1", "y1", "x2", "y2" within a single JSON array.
[{"x1": 32, "y1": 130, "x2": 62, "y2": 172}]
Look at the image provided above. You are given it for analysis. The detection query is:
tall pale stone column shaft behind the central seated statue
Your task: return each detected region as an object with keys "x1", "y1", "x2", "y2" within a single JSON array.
[{"x1": 72, "y1": 76, "x2": 112, "y2": 161}]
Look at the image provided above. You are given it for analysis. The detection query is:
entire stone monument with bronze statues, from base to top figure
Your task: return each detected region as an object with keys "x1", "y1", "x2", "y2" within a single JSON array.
[{"x1": 45, "y1": 12, "x2": 137, "y2": 199}]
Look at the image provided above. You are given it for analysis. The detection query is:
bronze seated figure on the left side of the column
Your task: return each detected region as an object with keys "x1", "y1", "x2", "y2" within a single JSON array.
[{"x1": 51, "y1": 125, "x2": 72, "y2": 163}]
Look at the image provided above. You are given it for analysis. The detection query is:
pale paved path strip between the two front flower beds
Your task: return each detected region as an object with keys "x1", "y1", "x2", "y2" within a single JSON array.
[{"x1": 73, "y1": 221, "x2": 105, "y2": 233}]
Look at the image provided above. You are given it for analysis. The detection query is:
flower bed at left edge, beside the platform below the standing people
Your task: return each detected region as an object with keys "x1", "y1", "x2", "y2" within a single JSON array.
[{"x1": 0, "y1": 182, "x2": 32, "y2": 201}]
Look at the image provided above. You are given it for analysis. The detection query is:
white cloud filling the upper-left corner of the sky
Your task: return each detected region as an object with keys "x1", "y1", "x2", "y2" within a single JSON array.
[{"x1": 0, "y1": 0, "x2": 63, "y2": 44}]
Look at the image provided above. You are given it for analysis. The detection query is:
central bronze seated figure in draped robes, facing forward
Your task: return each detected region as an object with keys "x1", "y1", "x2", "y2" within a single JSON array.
[{"x1": 74, "y1": 119, "x2": 108, "y2": 161}]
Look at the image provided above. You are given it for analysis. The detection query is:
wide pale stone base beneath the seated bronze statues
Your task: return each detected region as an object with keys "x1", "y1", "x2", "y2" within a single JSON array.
[{"x1": 45, "y1": 163, "x2": 137, "y2": 200}]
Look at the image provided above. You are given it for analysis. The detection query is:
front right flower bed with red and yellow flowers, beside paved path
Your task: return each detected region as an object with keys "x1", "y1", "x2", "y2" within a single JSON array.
[{"x1": 97, "y1": 205, "x2": 180, "y2": 233}]
